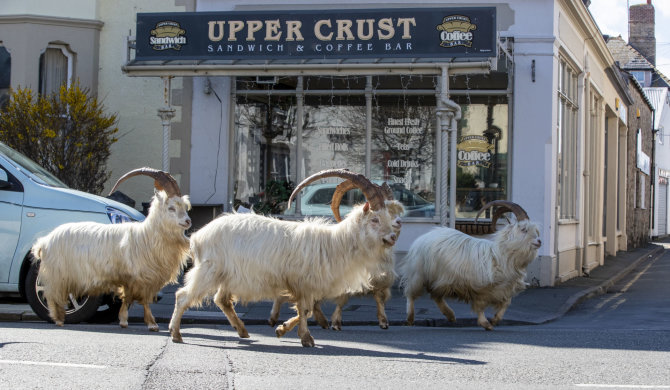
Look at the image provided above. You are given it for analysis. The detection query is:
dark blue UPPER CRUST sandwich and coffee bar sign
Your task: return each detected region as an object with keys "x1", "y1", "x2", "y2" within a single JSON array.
[{"x1": 135, "y1": 7, "x2": 496, "y2": 61}]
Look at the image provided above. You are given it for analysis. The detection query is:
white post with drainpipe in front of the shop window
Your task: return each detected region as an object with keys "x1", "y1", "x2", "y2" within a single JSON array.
[{"x1": 437, "y1": 65, "x2": 461, "y2": 228}]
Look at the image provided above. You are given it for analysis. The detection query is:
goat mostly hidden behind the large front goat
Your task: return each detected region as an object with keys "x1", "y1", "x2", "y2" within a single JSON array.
[{"x1": 268, "y1": 180, "x2": 405, "y2": 330}]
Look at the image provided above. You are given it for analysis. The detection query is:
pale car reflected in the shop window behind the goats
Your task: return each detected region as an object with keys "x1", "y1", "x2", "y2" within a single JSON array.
[{"x1": 284, "y1": 183, "x2": 435, "y2": 217}]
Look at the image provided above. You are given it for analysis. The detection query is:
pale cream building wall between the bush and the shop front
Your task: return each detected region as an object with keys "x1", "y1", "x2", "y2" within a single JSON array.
[{"x1": 98, "y1": 0, "x2": 191, "y2": 209}]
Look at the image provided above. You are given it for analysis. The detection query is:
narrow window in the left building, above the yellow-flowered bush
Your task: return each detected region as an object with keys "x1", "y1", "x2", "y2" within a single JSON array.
[{"x1": 39, "y1": 45, "x2": 74, "y2": 95}]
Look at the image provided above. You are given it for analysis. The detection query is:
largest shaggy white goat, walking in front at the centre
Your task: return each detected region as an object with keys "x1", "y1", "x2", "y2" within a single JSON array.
[{"x1": 170, "y1": 169, "x2": 398, "y2": 347}]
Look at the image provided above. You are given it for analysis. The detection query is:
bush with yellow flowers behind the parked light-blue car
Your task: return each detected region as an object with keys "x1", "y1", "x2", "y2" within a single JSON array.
[{"x1": 0, "y1": 84, "x2": 119, "y2": 194}]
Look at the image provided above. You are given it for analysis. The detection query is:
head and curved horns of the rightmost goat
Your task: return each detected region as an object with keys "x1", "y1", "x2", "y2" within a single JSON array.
[{"x1": 475, "y1": 200, "x2": 542, "y2": 266}]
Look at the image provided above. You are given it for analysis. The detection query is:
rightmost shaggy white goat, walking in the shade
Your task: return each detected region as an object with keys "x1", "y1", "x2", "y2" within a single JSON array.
[{"x1": 399, "y1": 201, "x2": 542, "y2": 330}]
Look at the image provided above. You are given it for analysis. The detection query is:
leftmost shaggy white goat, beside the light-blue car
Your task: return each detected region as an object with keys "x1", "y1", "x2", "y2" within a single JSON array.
[{"x1": 32, "y1": 168, "x2": 191, "y2": 331}]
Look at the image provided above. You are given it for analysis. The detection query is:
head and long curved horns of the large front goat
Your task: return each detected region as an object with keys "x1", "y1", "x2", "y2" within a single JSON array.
[{"x1": 288, "y1": 169, "x2": 404, "y2": 247}]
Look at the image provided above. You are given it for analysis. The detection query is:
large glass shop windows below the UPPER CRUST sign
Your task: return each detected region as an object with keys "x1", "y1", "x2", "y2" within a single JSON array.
[{"x1": 232, "y1": 75, "x2": 509, "y2": 220}]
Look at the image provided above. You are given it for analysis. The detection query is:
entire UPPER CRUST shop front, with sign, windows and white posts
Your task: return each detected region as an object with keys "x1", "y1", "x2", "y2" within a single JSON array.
[{"x1": 124, "y1": 7, "x2": 512, "y2": 247}]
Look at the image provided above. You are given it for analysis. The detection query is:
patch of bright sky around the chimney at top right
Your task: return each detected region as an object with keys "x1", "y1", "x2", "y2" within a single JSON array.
[{"x1": 589, "y1": 0, "x2": 670, "y2": 77}]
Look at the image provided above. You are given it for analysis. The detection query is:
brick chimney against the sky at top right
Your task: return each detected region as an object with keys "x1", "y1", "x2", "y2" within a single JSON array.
[{"x1": 628, "y1": 0, "x2": 656, "y2": 65}]
